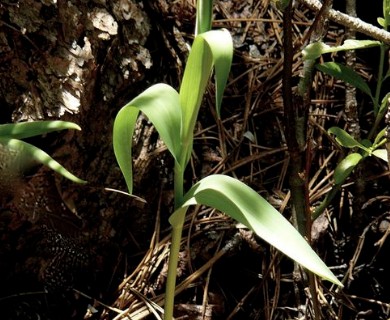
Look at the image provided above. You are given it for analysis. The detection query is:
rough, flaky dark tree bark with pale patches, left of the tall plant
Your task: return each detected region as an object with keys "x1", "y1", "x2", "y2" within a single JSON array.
[{"x1": 0, "y1": 0, "x2": 166, "y2": 319}]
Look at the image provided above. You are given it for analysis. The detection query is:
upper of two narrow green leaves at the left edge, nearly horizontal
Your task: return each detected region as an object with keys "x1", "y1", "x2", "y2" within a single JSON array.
[{"x1": 0, "y1": 120, "x2": 81, "y2": 139}]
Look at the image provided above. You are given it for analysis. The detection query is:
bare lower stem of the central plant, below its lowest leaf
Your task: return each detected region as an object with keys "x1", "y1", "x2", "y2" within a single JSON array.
[{"x1": 164, "y1": 221, "x2": 185, "y2": 320}]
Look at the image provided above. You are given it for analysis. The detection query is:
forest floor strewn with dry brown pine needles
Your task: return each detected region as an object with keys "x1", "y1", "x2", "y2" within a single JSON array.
[{"x1": 0, "y1": 0, "x2": 390, "y2": 320}]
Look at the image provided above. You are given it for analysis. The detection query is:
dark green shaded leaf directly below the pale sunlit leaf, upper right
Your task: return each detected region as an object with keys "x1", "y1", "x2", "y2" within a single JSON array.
[{"x1": 316, "y1": 62, "x2": 372, "y2": 99}]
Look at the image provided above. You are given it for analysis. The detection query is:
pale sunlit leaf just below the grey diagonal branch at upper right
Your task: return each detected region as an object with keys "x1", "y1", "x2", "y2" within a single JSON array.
[{"x1": 302, "y1": 39, "x2": 381, "y2": 60}]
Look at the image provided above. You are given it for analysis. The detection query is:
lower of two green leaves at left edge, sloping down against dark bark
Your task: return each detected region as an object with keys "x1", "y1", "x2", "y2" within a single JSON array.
[{"x1": 0, "y1": 138, "x2": 87, "y2": 183}]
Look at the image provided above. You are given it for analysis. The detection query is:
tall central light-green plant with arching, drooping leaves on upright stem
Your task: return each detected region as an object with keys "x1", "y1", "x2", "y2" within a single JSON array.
[{"x1": 113, "y1": 1, "x2": 342, "y2": 320}]
